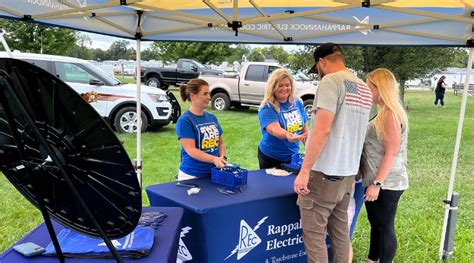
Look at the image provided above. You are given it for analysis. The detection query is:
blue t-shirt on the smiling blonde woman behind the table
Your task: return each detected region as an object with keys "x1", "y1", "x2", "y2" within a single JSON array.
[{"x1": 258, "y1": 99, "x2": 308, "y2": 162}]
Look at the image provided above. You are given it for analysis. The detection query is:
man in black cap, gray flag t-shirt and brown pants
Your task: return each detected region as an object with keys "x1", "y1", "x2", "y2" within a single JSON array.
[{"x1": 294, "y1": 43, "x2": 372, "y2": 263}]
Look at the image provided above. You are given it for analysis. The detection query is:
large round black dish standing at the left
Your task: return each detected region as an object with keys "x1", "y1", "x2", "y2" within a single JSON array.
[{"x1": 0, "y1": 58, "x2": 142, "y2": 262}]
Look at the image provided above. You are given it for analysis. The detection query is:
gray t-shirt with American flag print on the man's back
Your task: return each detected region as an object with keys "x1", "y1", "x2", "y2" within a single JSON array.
[{"x1": 308, "y1": 70, "x2": 372, "y2": 176}]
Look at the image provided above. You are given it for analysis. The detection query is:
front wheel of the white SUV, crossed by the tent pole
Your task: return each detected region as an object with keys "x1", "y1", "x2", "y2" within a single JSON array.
[{"x1": 114, "y1": 106, "x2": 148, "y2": 133}]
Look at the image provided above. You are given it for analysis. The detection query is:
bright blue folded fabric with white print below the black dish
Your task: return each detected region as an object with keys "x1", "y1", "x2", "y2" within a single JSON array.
[{"x1": 44, "y1": 226, "x2": 155, "y2": 258}]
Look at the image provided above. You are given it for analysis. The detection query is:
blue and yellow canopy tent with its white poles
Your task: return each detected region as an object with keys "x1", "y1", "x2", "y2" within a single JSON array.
[{"x1": 0, "y1": 0, "x2": 474, "y2": 256}]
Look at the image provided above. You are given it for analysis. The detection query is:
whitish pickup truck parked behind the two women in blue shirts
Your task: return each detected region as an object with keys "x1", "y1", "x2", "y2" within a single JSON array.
[{"x1": 200, "y1": 62, "x2": 317, "y2": 116}]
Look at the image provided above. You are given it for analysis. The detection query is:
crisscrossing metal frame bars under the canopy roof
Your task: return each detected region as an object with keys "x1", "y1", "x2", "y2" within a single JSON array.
[{"x1": 0, "y1": 0, "x2": 474, "y2": 42}]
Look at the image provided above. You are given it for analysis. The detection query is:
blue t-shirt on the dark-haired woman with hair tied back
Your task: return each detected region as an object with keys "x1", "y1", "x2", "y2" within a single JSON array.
[{"x1": 176, "y1": 111, "x2": 223, "y2": 177}]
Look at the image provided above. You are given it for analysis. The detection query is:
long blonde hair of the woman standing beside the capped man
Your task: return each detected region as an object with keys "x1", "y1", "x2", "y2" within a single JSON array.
[{"x1": 367, "y1": 68, "x2": 408, "y2": 141}]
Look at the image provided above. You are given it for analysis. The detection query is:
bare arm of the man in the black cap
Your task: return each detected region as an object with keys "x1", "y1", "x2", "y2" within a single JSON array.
[{"x1": 294, "y1": 108, "x2": 334, "y2": 195}]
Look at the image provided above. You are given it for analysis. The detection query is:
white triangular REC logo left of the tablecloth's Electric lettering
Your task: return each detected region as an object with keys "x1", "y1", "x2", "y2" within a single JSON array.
[{"x1": 224, "y1": 216, "x2": 268, "y2": 260}]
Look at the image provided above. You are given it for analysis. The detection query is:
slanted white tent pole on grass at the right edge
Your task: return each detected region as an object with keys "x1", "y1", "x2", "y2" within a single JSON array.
[{"x1": 439, "y1": 48, "x2": 474, "y2": 260}]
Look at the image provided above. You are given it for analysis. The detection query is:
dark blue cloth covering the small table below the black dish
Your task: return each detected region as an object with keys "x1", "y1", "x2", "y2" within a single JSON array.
[{"x1": 0, "y1": 207, "x2": 183, "y2": 263}]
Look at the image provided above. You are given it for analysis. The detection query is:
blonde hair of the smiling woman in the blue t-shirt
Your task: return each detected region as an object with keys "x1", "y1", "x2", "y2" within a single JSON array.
[{"x1": 260, "y1": 68, "x2": 296, "y2": 112}]
